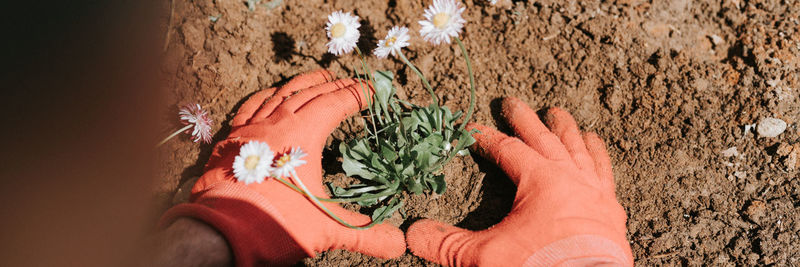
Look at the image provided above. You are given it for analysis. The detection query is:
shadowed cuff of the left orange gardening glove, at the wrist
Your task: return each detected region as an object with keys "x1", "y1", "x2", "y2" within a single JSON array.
[{"x1": 158, "y1": 181, "x2": 314, "y2": 266}]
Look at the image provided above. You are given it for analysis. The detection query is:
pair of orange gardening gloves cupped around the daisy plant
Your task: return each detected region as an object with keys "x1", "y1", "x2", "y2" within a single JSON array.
[{"x1": 160, "y1": 70, "x2": 633, "y2": 266}]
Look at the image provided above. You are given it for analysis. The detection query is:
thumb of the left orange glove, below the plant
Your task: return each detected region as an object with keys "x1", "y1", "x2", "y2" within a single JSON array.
[{"x1": 329, "y1": 209, "x2": 406, "y2": 259}]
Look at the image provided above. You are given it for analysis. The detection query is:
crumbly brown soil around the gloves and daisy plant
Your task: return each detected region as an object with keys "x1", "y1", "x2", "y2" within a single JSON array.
[{"x1": 156, "y1": 0, "x2": 800, "y2": 266}]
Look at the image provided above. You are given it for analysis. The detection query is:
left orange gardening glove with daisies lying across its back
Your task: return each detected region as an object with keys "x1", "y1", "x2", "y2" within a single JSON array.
[{"x1": 160, "y1": 70, "x2": 406, "y2": 266}]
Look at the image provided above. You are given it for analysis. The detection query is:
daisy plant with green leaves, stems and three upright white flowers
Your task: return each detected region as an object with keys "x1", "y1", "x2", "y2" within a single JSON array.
[{"x1": 284, "y1": 0, "x2": 475, "y2": 229}]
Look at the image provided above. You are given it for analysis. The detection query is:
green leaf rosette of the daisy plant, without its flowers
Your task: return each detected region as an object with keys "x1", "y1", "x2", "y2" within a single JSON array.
[{"x1": 329, "y1": 65, "x2": 475, "y2": 226}]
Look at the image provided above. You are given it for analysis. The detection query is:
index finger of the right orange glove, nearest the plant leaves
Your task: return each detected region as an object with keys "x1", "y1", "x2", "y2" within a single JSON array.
[{"x1": 467, "y1": 123, "x2": 540, "y2": 185}]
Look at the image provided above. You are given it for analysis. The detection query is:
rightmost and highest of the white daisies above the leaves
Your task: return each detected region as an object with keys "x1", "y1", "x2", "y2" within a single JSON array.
[{"x1": 419, "y1": 0, "x2": 467, "y2": 45}]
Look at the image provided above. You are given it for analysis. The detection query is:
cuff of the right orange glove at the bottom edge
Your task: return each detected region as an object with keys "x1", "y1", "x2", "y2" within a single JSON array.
[{"x1": 522, "y1": 235, "x2": 633, "y2": 266}]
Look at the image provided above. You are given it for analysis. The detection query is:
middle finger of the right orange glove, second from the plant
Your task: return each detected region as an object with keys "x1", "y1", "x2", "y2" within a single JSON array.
[{"x1": 503, "y1": 97, "x2": 570, "y2": 160}]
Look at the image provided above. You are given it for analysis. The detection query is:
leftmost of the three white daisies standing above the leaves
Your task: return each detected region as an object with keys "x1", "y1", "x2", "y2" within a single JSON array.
[{"x1": 325, "y1": 11, "x2": 361, "y2": 56}]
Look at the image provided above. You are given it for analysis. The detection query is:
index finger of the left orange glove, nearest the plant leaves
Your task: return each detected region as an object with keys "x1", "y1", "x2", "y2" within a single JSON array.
[{"x1": 295, "y1": 83, "x2": 374, "y2": 136}]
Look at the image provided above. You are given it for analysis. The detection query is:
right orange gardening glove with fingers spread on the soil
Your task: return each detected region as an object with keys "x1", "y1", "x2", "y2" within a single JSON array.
[{"x1": 406, "y1": 98, "x2": 633, "y2": 266}]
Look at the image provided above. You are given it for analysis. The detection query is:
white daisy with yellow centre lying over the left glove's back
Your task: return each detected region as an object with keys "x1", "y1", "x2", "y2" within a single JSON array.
[{"x1": 233, "y1": 141, "x2": 275, "y2": 184}]
